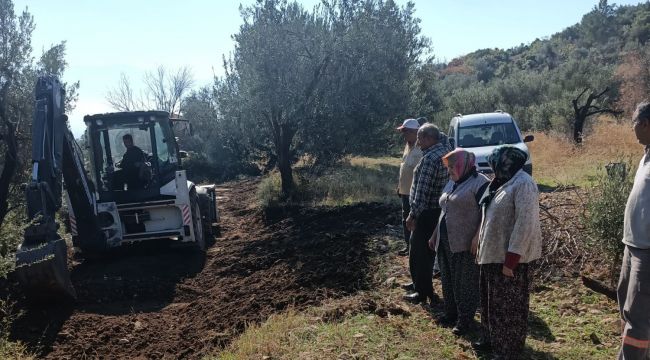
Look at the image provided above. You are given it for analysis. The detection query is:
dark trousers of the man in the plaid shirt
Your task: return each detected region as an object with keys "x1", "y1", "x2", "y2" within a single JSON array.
[{"x1": 409, "y1": 209, "x2": 440, "y2": 300}]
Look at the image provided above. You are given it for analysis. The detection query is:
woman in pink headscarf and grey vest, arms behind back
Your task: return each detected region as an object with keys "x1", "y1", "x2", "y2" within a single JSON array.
[{"x1": 429, "y1": 149, "x2": 489, "y2": 335}]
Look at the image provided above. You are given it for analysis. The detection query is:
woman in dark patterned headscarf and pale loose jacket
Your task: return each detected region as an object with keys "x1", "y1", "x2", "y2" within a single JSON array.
[{"x1": 474, "y1": 146, "x2": 542, "y2": 359}]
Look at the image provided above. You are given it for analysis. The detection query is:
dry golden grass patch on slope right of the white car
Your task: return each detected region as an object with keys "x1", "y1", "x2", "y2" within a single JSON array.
[{"x1": 529, "y1": 117, "x2": 643, "y2": 186}]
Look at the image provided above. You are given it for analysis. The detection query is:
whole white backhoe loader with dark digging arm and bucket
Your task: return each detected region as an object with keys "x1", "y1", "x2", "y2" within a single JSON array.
[{"x1": 15, "y1": 76, "x2": 219, "y2": 299}]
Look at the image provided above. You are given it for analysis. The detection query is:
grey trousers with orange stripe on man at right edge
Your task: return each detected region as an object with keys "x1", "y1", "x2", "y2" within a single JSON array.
[{"x1": 618, "y1": 245, "x2": 650, "y2": 360}]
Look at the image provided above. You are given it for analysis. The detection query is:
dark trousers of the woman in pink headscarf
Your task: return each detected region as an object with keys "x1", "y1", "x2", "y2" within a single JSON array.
[{"x1": 438, "y1": 221, "x2": 480, "y2": 324}]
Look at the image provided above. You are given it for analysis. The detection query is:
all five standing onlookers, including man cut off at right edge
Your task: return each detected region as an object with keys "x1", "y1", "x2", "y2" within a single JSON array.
[{"x1": 398, "y1": 102, "x2": 650, "y2": 360}]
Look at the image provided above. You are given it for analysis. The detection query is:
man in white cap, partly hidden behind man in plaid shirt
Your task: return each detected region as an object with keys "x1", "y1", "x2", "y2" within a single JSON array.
[{"x1": 397, "y1": 119, "x2": 422, "y2": 256}]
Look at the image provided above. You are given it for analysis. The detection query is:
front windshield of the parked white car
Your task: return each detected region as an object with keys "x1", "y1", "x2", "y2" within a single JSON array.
[{"x1": 458, "y1": 123, "x2": 521, "y2": 148}]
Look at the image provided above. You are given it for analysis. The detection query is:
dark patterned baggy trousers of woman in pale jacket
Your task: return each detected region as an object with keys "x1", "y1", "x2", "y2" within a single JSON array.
[{"x1": 480, "y1": 264, "x2": 530, "y2": 359}]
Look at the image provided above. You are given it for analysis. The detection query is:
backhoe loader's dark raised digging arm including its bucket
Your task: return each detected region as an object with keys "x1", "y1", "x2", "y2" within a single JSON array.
[{"x1": 15, "y1": 76, "x2": 105, "y2": 299}]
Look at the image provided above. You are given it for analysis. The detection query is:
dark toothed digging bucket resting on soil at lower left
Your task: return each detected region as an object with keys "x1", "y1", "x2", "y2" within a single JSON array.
[{"x1": 14, "y1": 239, "x2": 77, "y2": 301}]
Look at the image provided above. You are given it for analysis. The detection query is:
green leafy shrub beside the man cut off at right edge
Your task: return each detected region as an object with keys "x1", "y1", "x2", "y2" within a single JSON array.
[{"x1": 584, "y1": 163, "x2": 634, "y2": 259}]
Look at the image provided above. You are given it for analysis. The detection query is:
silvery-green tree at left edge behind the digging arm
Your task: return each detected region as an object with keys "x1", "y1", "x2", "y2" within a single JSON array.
[{"x1": 0, "y1": 0, "x2": 79, "y2": 231}]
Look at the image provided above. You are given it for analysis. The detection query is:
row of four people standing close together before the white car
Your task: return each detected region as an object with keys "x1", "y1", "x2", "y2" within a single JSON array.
[{"x1": 398, "y1": 119, "x2": 542, "y2": 359}]
